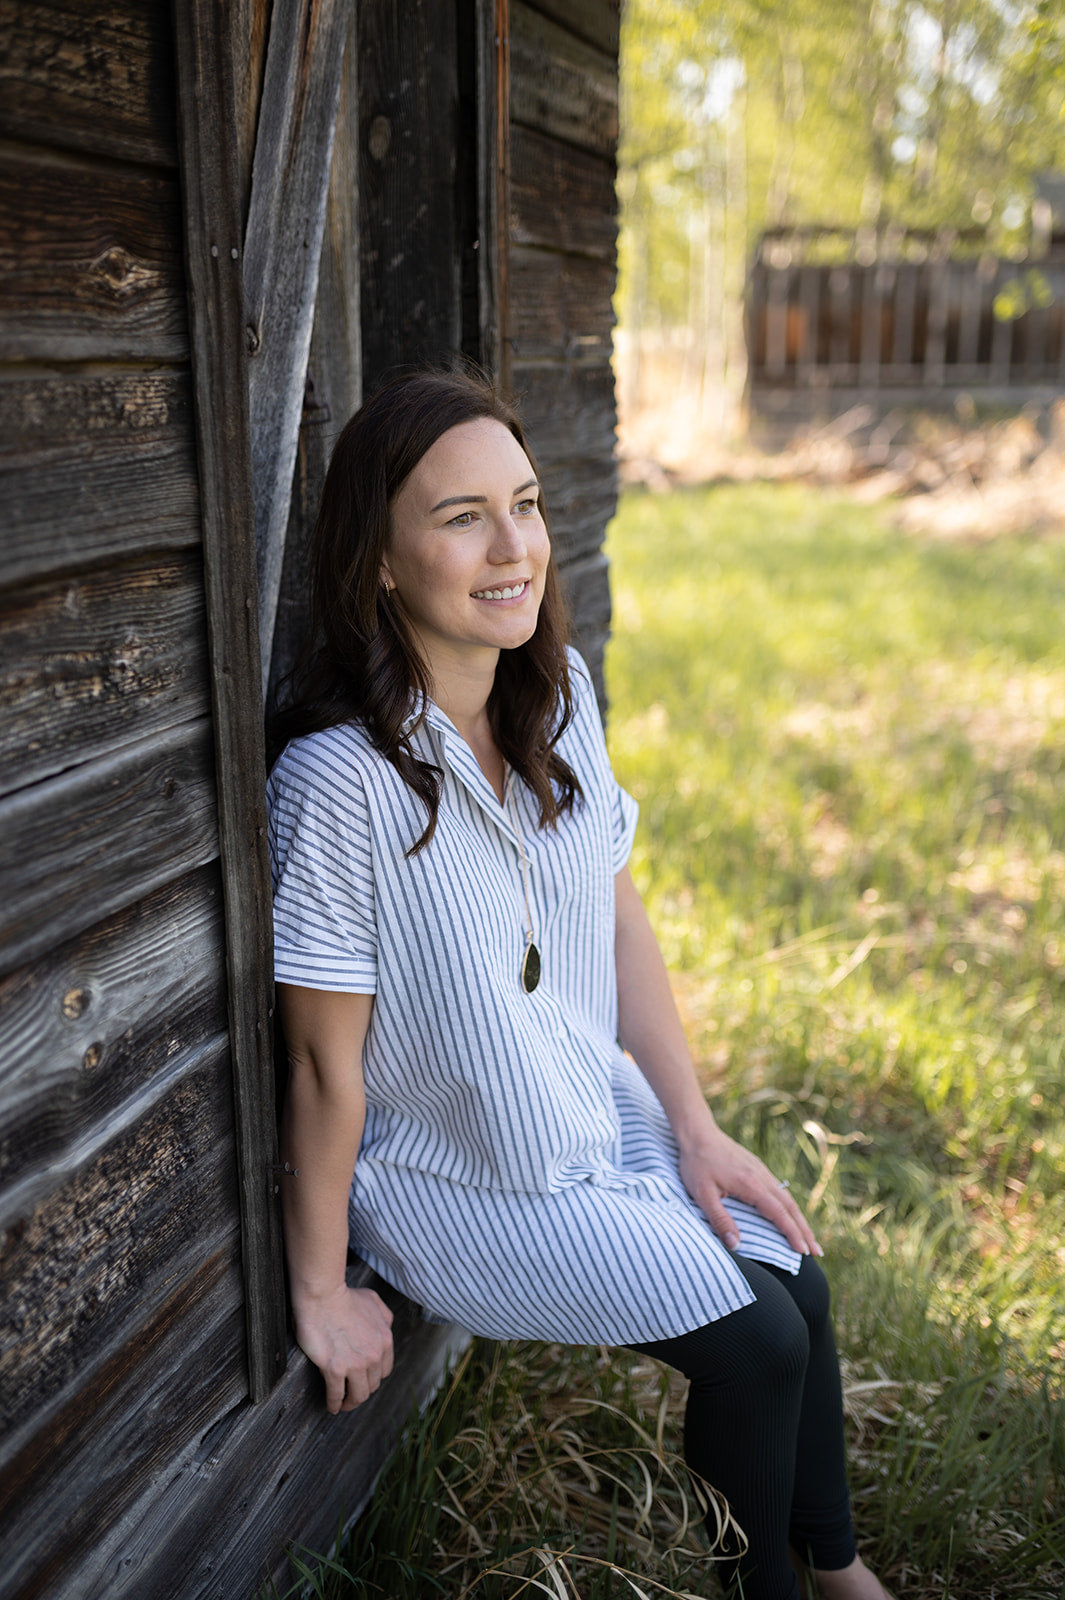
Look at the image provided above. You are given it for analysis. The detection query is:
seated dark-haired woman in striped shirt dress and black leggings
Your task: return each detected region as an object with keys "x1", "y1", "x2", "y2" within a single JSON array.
[{"x1": 270, "y1": 373, "x2": 884, "y2": 1600}]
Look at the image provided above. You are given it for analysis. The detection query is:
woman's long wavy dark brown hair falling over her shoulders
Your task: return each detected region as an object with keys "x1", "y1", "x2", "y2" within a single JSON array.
[{"x1": 269, "y1": 371, "x2": 580, "y2": 856}]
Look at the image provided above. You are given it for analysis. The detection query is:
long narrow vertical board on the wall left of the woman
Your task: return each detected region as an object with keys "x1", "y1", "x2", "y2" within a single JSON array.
[{"x1": 174, "y1": 0, "x2": 285, "y2": 1398}]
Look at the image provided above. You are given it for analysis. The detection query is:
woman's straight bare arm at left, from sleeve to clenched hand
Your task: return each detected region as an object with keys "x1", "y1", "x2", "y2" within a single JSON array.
[{"x1": 278, "y1": 984, "x2": 392, "y2": 1413}]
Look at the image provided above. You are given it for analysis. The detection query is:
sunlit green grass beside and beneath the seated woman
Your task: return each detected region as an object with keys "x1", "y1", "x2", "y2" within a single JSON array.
[{"x1": 259, "y1": 486, "x2": 1065, "y2": 1600}]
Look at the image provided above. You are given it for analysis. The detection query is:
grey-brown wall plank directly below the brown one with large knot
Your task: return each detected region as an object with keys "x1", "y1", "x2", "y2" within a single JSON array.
[{"x1": 0, "y1": 370, "x2": 200, "y2": 586}]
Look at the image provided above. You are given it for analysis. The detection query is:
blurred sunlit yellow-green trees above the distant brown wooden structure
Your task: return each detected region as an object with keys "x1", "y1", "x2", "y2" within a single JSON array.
[{"x1": 620, "y1": 0, "x2": 1065, "y2": 331}]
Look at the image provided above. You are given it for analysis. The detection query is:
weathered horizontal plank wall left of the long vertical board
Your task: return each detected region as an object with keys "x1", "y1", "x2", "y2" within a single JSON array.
[{"x1": 0, "y1": 0, "x2": 453, "y2": 1600}]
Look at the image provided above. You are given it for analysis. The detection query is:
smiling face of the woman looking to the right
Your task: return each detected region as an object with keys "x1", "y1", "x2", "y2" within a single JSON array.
[{"x1": 381, "y1": 418, "x2": 550, "y2": 677}]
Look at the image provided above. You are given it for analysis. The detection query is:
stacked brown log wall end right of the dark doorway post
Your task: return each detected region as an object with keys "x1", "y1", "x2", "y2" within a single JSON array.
[{"x1": 505, "y1": 0, "x2": 620, "y2": 694}]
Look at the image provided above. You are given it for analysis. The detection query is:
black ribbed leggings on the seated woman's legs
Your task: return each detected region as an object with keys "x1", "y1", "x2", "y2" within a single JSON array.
[{"x1": 632, "y1": 1256, "x2": 856, "y2": 1600}]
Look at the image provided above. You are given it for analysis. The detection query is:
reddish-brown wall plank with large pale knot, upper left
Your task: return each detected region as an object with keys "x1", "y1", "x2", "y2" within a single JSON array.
[{"x1": 0, "y1": 150, "x2": 189, "y2": 362}]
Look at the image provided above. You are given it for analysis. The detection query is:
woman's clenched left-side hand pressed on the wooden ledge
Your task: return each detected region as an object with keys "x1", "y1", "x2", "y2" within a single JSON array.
[{"x1": 293, "y1": 1285, "x2": 392, "y2": 1416}]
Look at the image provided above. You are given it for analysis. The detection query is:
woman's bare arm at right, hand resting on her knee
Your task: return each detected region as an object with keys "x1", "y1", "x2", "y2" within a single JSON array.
[{"x1": 614, "y1": 867, "x2": 822, "y2": 1256}]
